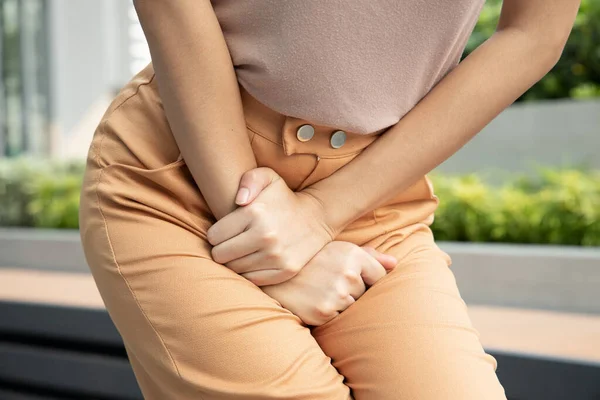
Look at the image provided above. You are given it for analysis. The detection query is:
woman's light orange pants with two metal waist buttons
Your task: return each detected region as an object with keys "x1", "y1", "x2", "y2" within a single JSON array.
[{"x1": 80, "y1": 66, "x2": 505, "y2": 400}]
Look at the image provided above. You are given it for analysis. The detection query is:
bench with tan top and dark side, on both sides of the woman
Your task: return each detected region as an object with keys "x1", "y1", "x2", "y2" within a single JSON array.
[{"x1": 0, "y1": 268, "x2": 600, "y2": 400}]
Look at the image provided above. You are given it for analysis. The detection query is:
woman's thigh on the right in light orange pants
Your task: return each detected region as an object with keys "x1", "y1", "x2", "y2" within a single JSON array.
[{"x1": 313, "y1": 229, "x2": 506, "y2": 400}]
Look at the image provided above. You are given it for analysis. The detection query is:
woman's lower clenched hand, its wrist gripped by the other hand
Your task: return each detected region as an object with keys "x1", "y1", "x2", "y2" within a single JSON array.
[{"x1": 262, "y1": 241, "x2": 397, "y2": 326}]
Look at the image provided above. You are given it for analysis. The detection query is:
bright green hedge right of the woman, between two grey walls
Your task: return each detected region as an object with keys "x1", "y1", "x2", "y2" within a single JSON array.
[{"x1": 432, "y1": 169, "x2": 600, "y2": 246}]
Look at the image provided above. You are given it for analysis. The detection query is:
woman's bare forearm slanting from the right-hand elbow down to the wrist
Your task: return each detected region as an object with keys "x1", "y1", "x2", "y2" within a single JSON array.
[{"x1": 306, "y1": 2, "x2": 576, "y2": 232}]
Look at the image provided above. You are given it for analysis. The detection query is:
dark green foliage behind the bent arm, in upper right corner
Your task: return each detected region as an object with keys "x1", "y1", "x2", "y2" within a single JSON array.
[{"x1": 464, "y1": 0, "x2": 600, "y2": 101}]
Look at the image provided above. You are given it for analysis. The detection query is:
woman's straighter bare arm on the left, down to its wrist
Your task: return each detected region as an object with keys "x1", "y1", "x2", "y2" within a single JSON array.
[{"x1": 134, "y1": 0, "x2": 256, "y2": 218}]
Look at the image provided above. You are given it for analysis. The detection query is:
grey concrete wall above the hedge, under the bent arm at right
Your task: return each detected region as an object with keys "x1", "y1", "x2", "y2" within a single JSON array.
[{"x1": 438, "y1": 99, "x2": 600, "y2": 177}]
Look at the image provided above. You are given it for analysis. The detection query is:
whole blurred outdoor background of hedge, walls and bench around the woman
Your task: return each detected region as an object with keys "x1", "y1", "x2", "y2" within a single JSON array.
[{"x1": 0, "y1": 0, "x2": 600, "y2": 400}]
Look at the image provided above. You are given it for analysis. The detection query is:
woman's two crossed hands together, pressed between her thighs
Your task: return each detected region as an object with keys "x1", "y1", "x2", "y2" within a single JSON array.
[{"x1": 208, "y1": 168, "x2": 397, "y2": 325}]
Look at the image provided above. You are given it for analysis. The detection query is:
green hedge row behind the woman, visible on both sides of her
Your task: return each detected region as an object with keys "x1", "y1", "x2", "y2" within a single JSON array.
[{"x1": 0, "y1": 158, "x2": 600, "y2": 246}]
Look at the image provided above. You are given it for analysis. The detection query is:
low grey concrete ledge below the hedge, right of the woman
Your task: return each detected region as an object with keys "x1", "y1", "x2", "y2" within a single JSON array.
[{"x1": 439, "y1": 242, "x2": 600, "y2": 314}]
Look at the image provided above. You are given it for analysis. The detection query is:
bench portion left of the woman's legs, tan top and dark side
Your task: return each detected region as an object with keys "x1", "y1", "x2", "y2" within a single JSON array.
[{"x1": 0, "y1": 269, "x2": 142, "y2": 400}]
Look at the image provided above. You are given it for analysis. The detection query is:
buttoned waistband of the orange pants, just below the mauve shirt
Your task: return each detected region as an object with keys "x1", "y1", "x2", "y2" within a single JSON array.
[{"x1": 240, "y1": 85, "x2": 385, "y2": 158}]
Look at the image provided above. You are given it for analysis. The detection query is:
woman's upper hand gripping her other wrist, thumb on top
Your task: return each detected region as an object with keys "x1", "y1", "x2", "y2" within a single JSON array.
[{"x1": 207, "y1": 168, "x2": 334, "y2": 286}]
